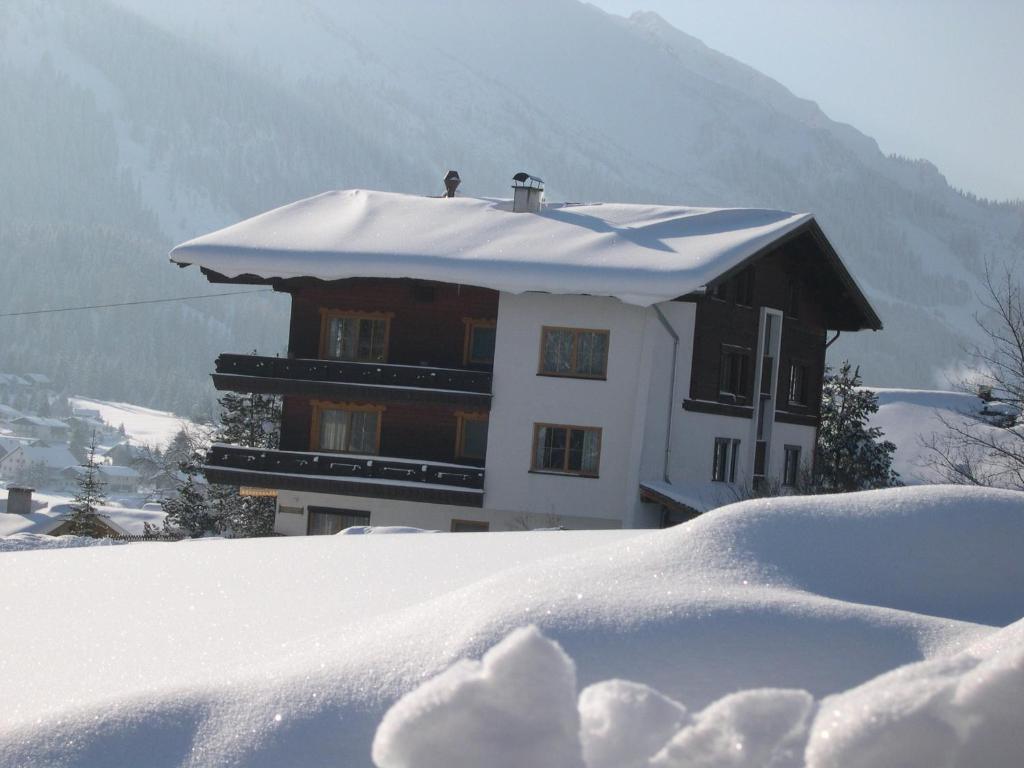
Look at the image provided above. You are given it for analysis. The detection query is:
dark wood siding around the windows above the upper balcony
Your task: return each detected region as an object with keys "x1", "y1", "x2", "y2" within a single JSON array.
[{"x1": 288, "y1": 278, "x2": 498, "y2": 368}]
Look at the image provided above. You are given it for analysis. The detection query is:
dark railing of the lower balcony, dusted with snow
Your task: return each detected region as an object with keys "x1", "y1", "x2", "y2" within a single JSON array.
[{"x1": 206, "y1": 443, "x2": 483, "y2": 490}]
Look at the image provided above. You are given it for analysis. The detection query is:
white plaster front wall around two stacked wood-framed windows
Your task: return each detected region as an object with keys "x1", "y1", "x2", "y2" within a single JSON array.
[{"x1": 484, "y1": 293, "x2": 647, "y2": 523}]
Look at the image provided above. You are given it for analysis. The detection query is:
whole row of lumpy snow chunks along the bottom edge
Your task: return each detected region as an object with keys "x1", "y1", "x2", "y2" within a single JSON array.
[{"x1": 373, "y1": 621, "x2": 1024, "y2": 768}]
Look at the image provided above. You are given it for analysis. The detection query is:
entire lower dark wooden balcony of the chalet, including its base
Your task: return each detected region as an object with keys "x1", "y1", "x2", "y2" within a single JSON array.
[{"x1": 203, "y1": 443, "x2": 483, "y2": 507}]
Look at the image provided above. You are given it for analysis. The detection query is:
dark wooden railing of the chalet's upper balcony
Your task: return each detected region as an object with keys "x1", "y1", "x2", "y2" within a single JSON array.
[{"x1": 214, "y1": 354, "x2": 492, "y2": 395}]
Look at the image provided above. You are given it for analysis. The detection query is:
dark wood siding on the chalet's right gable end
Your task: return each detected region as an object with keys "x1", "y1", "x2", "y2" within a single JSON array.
[{"x1": 690, "y1": 238, "x2": 825, "y2": 417}]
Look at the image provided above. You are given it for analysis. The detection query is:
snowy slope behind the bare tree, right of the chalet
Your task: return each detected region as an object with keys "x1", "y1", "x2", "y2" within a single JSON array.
[{"x1": 869, "y1": 387, "x2": 1015, "y2": 484}]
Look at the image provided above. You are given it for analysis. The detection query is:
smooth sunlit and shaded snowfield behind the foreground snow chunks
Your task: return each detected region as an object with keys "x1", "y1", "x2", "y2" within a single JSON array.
[{"x1": 0, "y1": 486, "x2": 1024, "y2": 768}]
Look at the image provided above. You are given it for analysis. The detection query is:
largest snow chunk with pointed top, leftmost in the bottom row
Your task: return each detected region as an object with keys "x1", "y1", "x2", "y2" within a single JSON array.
[{"x1": 373, "y1": 627, "x2": 583, "y2": 768}]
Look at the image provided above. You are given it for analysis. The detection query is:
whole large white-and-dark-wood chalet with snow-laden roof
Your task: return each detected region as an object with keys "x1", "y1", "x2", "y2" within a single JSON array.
[{"x1": 171, "y1": 172, "x2": 882, "y2": 535}]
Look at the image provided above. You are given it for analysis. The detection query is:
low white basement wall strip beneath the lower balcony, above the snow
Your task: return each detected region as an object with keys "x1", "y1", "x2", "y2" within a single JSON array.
[{"x1": 273, "y1": 490, "x2": 618, "y2": 536}]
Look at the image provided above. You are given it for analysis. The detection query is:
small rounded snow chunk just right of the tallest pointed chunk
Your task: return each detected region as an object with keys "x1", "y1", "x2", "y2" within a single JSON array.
[{"x1": 580, "y1": 680, "x2": 689, "y2": 768}]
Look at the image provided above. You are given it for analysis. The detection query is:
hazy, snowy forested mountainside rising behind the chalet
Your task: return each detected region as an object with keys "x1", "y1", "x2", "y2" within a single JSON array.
[{"x1": 0, "y1": 0, "x2": 1024, "y2": 415}]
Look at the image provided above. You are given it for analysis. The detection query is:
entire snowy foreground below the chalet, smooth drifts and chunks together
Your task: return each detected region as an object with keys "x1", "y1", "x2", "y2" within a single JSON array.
[{"x1": 0, "y1": 486, "x2": 1024, "y2": 768}]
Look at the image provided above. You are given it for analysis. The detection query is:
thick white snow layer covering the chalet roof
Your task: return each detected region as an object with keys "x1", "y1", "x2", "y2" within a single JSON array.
[{"x1": 171, "y1": 189, "x2": 812, "y2": 306}]
